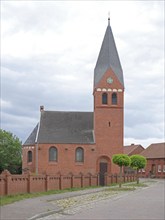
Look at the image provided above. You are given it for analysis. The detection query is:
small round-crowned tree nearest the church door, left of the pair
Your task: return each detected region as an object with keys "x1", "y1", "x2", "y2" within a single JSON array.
[{"x1": 112, "y1": 154, "x2": 131, "y2": 187}]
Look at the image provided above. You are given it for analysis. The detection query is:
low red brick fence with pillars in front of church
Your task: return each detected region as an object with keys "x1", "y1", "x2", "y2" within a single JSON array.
[{"x1": 0, "y1": 171, "x2": 137, "y2": 196}]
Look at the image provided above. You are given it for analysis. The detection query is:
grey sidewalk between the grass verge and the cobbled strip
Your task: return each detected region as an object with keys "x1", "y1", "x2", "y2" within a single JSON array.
[{"x1": 0, "y1": 187, "x2": 111, "y2": 220}]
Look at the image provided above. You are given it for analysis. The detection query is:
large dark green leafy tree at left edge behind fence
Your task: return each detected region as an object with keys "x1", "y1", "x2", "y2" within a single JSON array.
[{"x1": 0, "y1": 129, "x2": 22, "y2": 174}]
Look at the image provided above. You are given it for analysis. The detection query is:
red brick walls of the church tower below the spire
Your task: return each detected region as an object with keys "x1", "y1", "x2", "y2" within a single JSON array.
[{"x1": 94, "y1": 69, "x2": 124, "y2": 173}]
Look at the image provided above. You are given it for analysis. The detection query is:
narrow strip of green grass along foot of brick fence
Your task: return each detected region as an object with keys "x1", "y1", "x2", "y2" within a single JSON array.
[{"x1": 0, "y1": 186, "x2": 99, "y2": 206}]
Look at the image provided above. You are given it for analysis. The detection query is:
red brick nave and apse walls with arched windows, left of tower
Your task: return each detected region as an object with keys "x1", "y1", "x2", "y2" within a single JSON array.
[{"x1": 23, "y1": 144, "x2": 96, "y2": 175}]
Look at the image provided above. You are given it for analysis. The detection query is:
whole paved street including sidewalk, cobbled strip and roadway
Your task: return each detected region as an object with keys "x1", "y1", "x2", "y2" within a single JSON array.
[{"x1": 0, "y1": 180, "x2": 165, "y2": 220}]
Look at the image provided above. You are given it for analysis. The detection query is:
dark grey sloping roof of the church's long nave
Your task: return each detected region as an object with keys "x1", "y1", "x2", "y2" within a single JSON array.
[{"x1": 24, "y1": 111, "x2": 94, "y2": 145}]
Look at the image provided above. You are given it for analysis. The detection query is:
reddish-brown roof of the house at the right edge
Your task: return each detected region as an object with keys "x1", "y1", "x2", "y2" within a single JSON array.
[{"x1": 140, "y1": 143, "x2": 165, "y2": 159}]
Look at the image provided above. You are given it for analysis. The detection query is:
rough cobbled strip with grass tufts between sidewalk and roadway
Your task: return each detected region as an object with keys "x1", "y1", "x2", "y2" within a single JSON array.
[{"x1": 37, "y1": 179, "x2": 161, "y2": 220}]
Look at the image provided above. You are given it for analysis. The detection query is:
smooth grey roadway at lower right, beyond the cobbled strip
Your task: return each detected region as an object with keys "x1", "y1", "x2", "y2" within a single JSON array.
[{"x1": 40, "y1": 180, "x2": 165, "y2": 220}]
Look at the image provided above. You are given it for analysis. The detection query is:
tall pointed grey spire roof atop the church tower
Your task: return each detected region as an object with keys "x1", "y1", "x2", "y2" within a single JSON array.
[{"x1": 94, "y1": 24, "x2": 124, "y2": 87}]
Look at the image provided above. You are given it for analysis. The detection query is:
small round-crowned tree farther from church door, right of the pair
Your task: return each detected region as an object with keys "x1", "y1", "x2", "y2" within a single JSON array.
[{"x1": 130, "y1": 154, "x2": 147, "y2": 184}]
